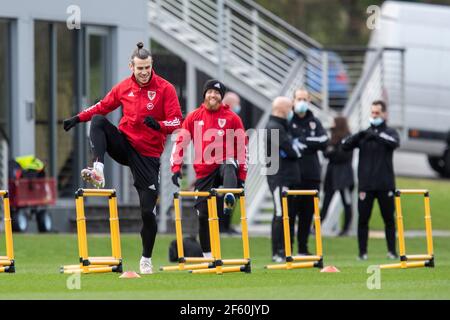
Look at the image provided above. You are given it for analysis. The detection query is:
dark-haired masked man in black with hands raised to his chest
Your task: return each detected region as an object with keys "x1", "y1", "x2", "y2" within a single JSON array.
[{"x1": 342, "y1": 100, "x2": 400, "y2": 260}]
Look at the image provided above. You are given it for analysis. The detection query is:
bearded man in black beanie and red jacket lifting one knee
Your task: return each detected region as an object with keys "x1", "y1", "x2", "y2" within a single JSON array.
[{"x1": 170, "y1": 80, "x2": 248, "y2": 258}]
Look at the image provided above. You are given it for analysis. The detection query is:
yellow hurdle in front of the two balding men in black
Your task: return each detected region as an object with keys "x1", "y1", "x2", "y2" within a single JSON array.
[{"x1": 266, "y1": 190, "x2": 323, "y2": 270}]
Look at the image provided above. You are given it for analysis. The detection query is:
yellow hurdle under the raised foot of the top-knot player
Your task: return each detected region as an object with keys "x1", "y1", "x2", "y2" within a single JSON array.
[{"x1": 61, "y1": 189, "x2": 122, "y2": 273}]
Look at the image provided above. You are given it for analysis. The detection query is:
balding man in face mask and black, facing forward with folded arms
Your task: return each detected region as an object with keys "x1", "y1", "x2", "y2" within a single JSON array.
[{"x1": 289, "y1": 89, "x2": 328, "y2": 255}]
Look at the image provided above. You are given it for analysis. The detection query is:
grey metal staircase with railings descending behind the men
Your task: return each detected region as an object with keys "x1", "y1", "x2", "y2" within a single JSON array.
[{"x1": 148, "y1": 0, "x2": 403, "y2": 234}]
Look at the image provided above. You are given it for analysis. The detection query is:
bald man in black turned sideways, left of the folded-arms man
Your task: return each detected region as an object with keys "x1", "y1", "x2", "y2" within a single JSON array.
[{"x1": 266, "y1": 97, "x2": 301, "y2": 262}]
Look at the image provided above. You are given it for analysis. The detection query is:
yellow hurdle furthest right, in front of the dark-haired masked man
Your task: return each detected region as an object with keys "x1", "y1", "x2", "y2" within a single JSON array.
[{"x1": 380, "y1": 189, "x2": 434, "y2": 269}]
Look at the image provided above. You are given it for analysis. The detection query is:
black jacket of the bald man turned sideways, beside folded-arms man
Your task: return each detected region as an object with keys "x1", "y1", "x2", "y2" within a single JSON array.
[{"x1": 266, "y1": 115, "x2": 301, "y2": 189}]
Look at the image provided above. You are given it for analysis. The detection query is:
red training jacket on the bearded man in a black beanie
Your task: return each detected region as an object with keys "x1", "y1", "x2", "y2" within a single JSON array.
[{"x1": 170, "y1": 104, "x2": 248, "y2": 181}]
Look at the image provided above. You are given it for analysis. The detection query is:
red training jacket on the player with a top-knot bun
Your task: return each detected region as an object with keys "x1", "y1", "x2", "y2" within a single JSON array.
[{"x1": 78, "y1": 70, "x2": 182, "y2": 158}]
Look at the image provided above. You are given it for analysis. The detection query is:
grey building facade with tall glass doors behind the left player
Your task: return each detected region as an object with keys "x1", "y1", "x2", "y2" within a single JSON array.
[{"x1": 0, "y1": 0, "x2": 150, "y2": 230}]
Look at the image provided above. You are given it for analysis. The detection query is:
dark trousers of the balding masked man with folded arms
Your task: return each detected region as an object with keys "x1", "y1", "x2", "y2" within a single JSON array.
[{"x1": 288, "y1": 180, "x2": 320, "y2": 254}]
